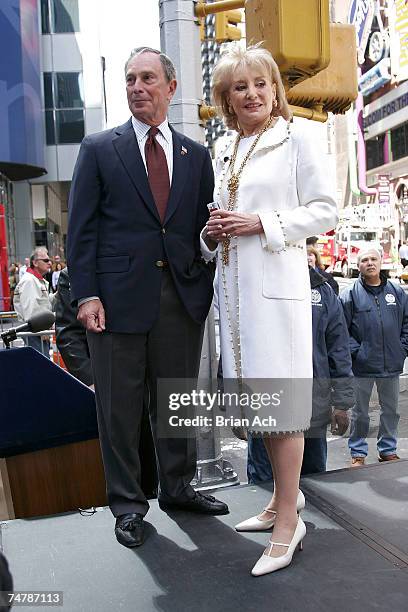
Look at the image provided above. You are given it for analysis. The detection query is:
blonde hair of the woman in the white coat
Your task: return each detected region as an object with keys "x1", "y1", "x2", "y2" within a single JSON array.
[{"x1": 212, "y1": 44, "x2": 292, "y2": 131}]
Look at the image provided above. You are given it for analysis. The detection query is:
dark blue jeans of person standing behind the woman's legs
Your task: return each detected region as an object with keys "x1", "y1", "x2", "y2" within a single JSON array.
[{"x1": 247, "y1": 427, "x2": 327, "y2": 484}]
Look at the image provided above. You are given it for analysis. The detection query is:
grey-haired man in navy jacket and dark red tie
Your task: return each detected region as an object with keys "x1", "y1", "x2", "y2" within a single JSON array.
[{"x1": 68, "y1": 47, "x2": 228, "y2": 546}]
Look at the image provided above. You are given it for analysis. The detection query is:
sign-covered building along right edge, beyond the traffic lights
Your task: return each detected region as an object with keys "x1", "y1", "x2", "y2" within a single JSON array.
[{"x1": 335, "y1": 0, "x2": 408, "y2": 251}]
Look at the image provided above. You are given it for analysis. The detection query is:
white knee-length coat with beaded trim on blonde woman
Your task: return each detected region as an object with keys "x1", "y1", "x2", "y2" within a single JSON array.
[{"x1": 202, "y1": 118, "x2": 337, "y2": 429}]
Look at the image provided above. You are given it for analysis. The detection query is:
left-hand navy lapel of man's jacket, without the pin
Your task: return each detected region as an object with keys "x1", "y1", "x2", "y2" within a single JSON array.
[{"x1": 113, "y1": 119, "x2": 160, "y2": 221}]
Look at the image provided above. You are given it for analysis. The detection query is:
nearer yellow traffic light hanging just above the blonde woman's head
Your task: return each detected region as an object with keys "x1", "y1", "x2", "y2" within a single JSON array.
[{"x1": 245, "y1": 0, "x2": 330, "y2": 87}]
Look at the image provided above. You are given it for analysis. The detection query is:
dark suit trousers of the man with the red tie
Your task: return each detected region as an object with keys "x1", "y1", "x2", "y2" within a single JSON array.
[{"x1": 87, "y1": 270, "x2": 204, "y2": 516}]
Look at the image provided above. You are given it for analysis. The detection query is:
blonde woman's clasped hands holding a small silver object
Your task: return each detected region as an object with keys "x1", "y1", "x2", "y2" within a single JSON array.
[{"x1": 207, "y1": 209, "x2": 263, "y2": 242}]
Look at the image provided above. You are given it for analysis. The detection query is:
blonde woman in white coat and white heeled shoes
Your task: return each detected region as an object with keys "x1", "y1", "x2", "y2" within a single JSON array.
[{"x1": 202, "y1": 46, "x2": 337, "y2": 576}]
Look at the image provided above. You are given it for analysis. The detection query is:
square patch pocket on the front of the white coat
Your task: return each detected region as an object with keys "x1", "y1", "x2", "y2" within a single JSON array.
[{"x1": 262, "y1": 248, "x2": 310, "y2": 300}]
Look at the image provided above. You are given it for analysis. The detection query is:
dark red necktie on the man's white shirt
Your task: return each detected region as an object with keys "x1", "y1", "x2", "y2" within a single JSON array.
[{"x1": 145, "y1": 127, "x2": 170, "y2": 223}]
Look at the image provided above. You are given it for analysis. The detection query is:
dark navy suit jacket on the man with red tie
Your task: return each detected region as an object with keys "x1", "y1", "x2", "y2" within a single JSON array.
[{"x1": 67, "y1": 120, "x2": 214, "y2": 333}]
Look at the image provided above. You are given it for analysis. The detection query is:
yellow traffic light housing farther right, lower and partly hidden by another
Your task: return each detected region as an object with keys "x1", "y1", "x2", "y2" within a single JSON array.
[{"x1": 287, "y1": 23, "x2": 357, "y2": 114}]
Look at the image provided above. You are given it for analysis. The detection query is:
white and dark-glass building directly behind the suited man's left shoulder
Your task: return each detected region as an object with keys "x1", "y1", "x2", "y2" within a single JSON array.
[{"x1": 31, "y1": 0, "x2": 105, "y2": 258}]
